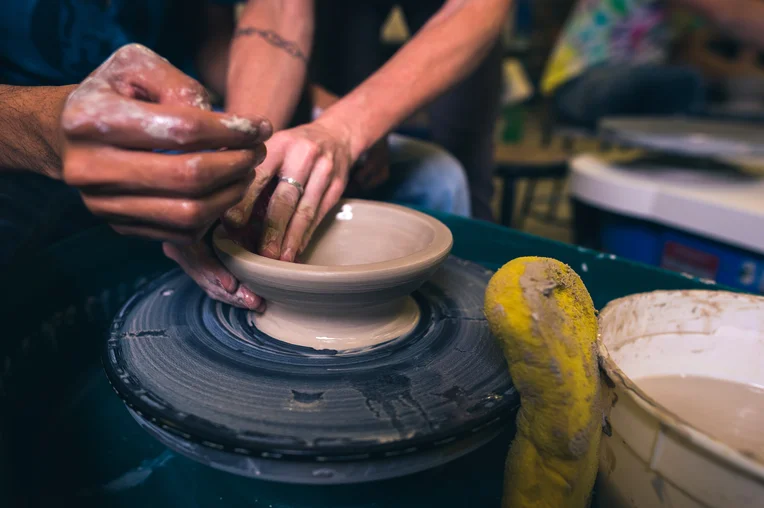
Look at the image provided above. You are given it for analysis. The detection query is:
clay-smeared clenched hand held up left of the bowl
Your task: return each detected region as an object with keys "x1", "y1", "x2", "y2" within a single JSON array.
[{"x1": 61, "y1": 44, "x2": 272, "y2": 244}]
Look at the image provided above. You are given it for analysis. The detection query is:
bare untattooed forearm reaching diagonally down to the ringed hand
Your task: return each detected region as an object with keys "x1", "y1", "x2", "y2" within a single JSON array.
[{"x1": 322, "y1": 0, "x2": 511, "y2": 158}]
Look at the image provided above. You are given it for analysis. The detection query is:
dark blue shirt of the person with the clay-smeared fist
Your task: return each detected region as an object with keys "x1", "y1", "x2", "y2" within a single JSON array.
[{"x1": 0, "y1": 0, "x2": 234, "y2": 268}]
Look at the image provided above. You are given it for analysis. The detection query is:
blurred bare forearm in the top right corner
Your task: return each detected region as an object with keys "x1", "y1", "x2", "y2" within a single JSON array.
[{"x1": 674, "y1": 0, "x2": 764, "y2": 49}]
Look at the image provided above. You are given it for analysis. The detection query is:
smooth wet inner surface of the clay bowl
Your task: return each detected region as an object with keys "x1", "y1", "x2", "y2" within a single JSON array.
[{"x1": 299, "y1": 201, "x2": 435, "y2": 266}]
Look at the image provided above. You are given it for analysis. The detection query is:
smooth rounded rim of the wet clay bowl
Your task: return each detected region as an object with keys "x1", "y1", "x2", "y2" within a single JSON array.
[{"x1": 212, "y1": 199, "x2": 453, "y2": 282}]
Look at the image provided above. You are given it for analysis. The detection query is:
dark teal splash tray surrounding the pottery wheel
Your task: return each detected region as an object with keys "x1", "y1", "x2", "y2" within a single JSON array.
[{"x1": 0, "y1": 211, "x2": 720, "y2": 508}]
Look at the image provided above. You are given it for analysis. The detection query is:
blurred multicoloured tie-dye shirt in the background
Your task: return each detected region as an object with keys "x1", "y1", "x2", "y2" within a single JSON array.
[{"x1": 541, "y1": 0, "x2": 670, "y2": 94}]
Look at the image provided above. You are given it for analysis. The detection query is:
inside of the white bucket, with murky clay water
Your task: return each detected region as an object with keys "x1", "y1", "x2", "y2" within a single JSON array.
[{"x1": 600, "y1": 291, "x2": 764, "y2": 463}]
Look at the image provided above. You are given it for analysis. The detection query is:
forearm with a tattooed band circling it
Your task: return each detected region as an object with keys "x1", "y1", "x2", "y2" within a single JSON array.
[{"x1": 226, "y1": 0, "x2": 314, "y2": 130}]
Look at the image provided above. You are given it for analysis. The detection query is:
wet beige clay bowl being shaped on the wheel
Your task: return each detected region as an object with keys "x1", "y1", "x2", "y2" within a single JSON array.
[{"x1": 213, "y1": 199, "x2": 453, "y2": 351}]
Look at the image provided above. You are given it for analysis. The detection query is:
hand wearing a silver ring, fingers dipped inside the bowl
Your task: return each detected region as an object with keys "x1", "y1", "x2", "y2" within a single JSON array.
[{"x1": 224, "y1": 118, "x2": 353, "y2": 261}]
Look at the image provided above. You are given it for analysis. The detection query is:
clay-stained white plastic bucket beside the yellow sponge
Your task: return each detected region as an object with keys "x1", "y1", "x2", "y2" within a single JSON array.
[{"x1": 598, "y1": 291, "x2": 764, "y2": 508}]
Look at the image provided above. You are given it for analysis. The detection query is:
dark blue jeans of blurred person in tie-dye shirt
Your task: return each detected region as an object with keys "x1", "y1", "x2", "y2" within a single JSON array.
[{"x1": 554, "y1": 64, "x2": 705, "y2": 130}]
